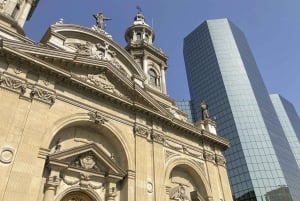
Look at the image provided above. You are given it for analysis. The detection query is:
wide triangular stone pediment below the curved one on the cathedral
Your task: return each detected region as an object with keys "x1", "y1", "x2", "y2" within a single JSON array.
[{"x1": 3, "y1": 38, "x2": 171, "y2": 117}]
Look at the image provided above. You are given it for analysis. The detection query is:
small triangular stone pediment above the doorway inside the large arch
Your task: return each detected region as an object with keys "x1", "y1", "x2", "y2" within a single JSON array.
[{"x1": 48, "y1": 143, "x2": 126, "y2": 178}]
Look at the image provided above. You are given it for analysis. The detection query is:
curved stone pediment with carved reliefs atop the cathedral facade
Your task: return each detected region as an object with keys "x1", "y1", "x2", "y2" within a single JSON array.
[{"x1": 41, "y1": 24, "x2": 145, "y2": 79}]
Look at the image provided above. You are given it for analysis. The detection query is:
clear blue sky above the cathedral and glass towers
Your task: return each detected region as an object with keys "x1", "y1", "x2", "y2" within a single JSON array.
[{"x1": 25, "y1": 0, "x2": 300, "y2": 113}]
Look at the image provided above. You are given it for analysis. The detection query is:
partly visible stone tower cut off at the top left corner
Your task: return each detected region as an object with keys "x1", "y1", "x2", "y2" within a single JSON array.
[{"x1": 0, "y1": 0, "x2": 39, "y2": 35}]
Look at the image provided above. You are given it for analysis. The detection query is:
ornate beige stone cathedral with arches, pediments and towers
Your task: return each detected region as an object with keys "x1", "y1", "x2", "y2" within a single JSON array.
[{"x1": 0, "y1": 0, "x2": 232, "y2": 201}]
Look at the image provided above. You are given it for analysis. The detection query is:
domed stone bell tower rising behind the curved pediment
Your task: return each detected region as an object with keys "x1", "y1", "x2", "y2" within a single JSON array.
[{"x1": 125, "y1": 7, "x2": 168, "y2": 94}]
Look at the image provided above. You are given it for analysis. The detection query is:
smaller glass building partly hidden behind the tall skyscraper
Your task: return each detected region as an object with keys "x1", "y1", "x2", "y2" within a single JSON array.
[{"x1": 270, "y1": 94, "x2": 300, "y2": 167}]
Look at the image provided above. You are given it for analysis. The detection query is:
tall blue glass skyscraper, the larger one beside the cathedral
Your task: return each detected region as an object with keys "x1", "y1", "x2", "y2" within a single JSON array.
[{"x1": 183, "y1": 19, "x2": 300, "y2": 201}]
